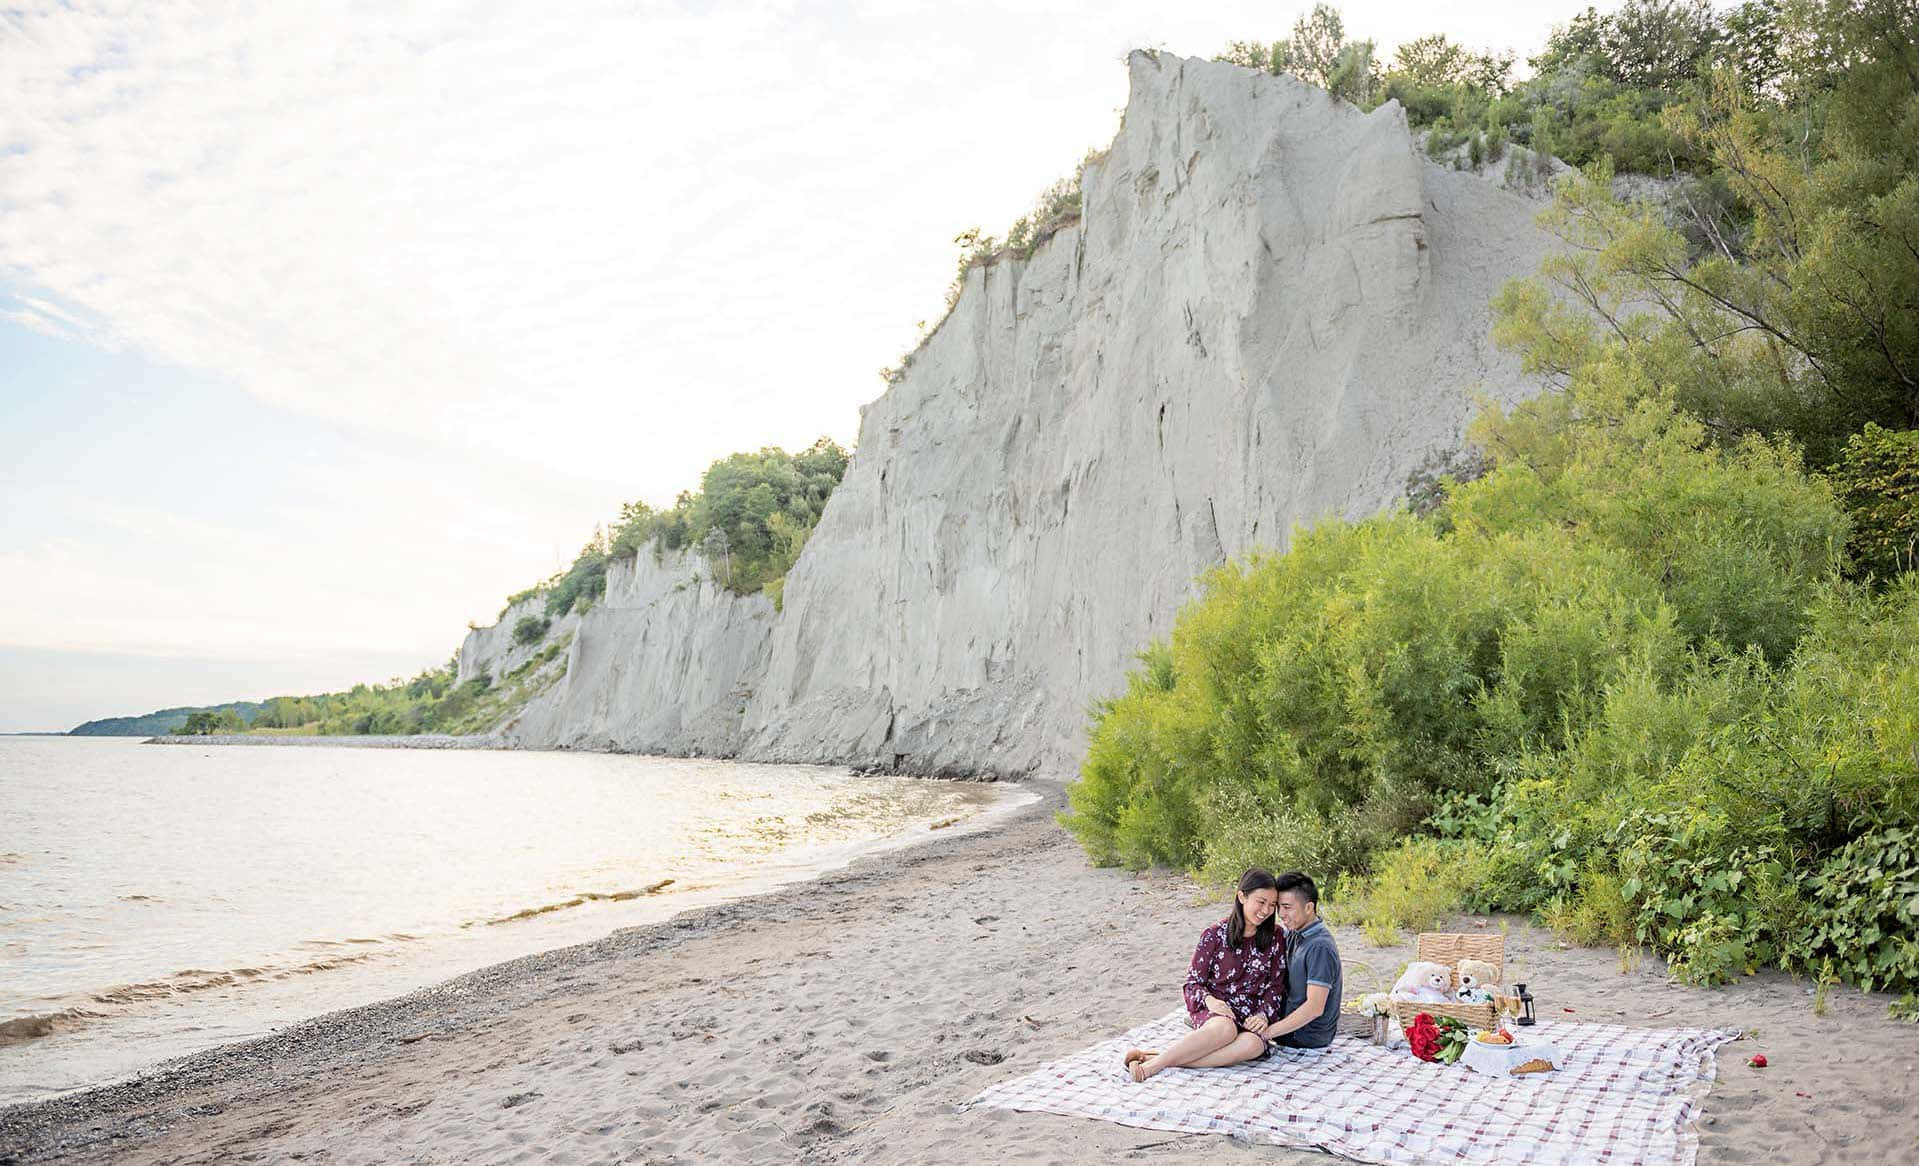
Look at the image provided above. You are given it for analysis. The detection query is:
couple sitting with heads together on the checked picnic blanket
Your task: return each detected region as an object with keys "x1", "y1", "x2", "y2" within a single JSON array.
[{"x1": 1125, "y1": 867, "x2": 1341, "y2": 1082}]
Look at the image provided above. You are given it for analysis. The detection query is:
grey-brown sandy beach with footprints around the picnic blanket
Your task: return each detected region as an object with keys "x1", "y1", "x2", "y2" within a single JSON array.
[{"x1": 0, "y1": 786, "x2": 1919, "y2": 1166}]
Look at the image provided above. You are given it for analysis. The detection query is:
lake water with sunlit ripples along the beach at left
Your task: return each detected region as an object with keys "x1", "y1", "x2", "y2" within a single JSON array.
[{"x1": 0, "y1": 738, "x2": 1025, "y2": 1105}]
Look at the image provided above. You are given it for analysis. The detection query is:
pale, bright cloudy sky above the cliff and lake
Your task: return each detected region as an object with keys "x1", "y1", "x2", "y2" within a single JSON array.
[{"x1": 0, "y1": 0, "x2": 1585, "y2": 733}]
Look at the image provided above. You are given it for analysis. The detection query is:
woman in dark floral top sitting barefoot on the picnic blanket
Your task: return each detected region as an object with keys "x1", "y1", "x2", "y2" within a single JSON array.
[{"x1": 1125, "y1": 867, "x2": 1286, "y2": 1082}]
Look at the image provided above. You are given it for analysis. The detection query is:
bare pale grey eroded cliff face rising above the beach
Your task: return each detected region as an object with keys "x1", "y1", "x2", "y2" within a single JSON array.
[{"x1": 464, "y1": 54, "x2": 1549, "y2": 777}]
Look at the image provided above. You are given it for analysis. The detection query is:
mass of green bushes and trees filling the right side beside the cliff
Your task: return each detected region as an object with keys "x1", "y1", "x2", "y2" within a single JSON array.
[{"x1": 1063, "y1": 0, "x2": 1919, "y2": 1018}]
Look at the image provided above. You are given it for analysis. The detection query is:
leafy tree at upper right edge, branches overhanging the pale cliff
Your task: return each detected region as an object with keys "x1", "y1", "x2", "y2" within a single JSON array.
[{"x1": 1495, "y1": 12, "x2": 1919, "y2": 466}]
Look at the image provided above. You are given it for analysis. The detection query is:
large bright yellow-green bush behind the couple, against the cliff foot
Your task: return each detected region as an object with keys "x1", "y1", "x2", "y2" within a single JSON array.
[{"x1": 1065, "y1": 389, "x2": 1842, "y2": 874}]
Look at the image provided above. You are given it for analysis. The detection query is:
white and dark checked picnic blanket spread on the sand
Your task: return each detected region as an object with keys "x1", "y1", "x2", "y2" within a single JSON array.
[{"x1": 967, "y1": 1013, "x2": 1739, "y2": 1166}]
